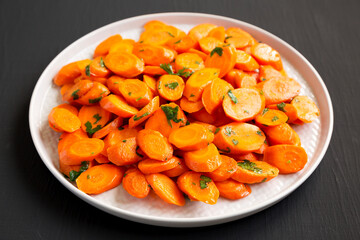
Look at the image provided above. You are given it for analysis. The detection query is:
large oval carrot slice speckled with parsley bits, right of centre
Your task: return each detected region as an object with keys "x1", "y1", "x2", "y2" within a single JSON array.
[{"x1": 214, "y1": 123, "x2": 265, "y2": 154}]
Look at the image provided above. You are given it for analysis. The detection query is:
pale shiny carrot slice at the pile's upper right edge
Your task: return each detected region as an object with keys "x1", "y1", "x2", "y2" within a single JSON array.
[{"x1": 251, "y1": 43, "x2": 283, "y2": 71}]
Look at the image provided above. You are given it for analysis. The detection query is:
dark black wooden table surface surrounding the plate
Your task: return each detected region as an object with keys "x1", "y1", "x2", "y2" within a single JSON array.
[{"x1": 0, "y1": 0, "x2": 360, "y2": 240}]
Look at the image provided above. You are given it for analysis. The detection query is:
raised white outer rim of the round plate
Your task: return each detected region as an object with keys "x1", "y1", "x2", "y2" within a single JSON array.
[{"x1": 29, "y1": 12, "x2": 334, "y2": 227}]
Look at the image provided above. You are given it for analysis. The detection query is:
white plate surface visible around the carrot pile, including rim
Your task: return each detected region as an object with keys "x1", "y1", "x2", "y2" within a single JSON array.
[{"x1": 29, "y1": 13, "x2": 333, "y2": 227}]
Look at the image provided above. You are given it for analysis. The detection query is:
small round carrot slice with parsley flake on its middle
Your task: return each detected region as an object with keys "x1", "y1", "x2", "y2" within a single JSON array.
[{"x1": 157, "y1": 74, "x2": 185, "y2": 101}]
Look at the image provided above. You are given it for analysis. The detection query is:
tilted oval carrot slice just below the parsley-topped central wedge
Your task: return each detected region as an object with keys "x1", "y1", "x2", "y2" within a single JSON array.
[{"x1": 136, "y1": 129, "x2": 173, "y2": 161}]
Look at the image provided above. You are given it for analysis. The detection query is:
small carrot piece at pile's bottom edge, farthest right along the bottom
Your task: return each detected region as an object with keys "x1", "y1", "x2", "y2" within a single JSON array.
[{"x1": 215, "y1": 179, "x2": 251, "y2": 200}]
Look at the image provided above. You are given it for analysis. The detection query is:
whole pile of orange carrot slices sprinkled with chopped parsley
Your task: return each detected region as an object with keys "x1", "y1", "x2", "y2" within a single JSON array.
[{"x1": 49, "y1": 21, "x2": 320, "y2": 206}]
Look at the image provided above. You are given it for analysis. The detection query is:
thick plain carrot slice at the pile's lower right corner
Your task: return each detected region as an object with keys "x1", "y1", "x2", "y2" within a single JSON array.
[{"x1": 264, "y1": 145, "x2": 308, "y2": 174}]
